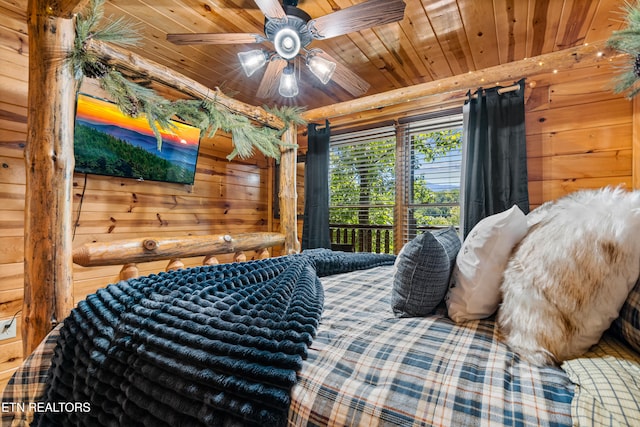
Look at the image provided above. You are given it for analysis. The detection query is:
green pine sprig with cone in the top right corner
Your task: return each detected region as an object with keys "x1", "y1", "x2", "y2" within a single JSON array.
[{"x1": 607, "y1": 1, "x2": 640, "y2": 99}]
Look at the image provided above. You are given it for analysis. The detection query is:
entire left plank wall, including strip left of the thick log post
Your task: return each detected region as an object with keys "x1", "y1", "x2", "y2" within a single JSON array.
[{"x1": 0, "y1": 2, "x2": 273, "y2": 390}]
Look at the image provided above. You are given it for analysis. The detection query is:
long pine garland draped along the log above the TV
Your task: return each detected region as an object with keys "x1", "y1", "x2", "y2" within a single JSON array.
[{"x1": 69, "y1": 0, "x2": 304, "y2": 160}]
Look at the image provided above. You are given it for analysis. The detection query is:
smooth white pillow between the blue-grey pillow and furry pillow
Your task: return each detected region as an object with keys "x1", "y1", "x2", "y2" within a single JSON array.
[{"x1": 445, "y1": 205, "x2": 528, "y2": 322}]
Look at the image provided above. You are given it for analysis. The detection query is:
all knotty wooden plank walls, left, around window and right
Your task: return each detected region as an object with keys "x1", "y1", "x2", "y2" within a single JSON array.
[{"x1": 0, "y1": 0, "x2": 638, "y2": 389}]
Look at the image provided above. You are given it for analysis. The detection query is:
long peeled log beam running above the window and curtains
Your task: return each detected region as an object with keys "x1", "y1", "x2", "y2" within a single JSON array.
[{"x1": 302, "y1": 42, "x2": 616, "y2": 122}]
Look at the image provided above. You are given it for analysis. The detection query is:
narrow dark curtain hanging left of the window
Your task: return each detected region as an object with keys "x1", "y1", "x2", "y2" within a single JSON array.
[{"x1": 302, "y1": 121, "x2": 331, "y2": 250}]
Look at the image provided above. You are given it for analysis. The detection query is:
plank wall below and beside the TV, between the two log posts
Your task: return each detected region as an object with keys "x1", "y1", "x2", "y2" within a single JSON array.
[{"x1": 73, "y1": 130, "x2": 269, "y2": 302}]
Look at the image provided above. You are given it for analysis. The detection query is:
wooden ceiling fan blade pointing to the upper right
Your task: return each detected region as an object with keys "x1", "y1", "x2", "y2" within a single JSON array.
[{"x1": 309, "y1": 0, "x2": 406, "y2": 39}]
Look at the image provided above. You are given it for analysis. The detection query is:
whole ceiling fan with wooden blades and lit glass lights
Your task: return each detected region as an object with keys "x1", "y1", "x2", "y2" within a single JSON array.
[{"x1": 167, "y1": 0, "x2": 405, "y2": 98}]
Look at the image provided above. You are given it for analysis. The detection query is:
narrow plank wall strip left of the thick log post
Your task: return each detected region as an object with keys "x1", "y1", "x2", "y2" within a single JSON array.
[{"x1": 0, "y1": 3, "x2": 28, "y2": 388}]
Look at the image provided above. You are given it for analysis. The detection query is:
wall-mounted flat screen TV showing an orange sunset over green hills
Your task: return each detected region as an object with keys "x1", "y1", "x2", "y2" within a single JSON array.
[{"x1": 74, "y1": 93, "x2": 200, "y2": 184}]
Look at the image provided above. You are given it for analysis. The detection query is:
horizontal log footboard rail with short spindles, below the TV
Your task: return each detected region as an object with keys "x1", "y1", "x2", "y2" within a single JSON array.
[{"x1": 73, "y1": 232, "x2": 285, "y2": 280}]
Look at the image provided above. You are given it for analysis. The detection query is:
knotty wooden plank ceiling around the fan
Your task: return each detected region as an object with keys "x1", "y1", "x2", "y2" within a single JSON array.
[{"x1": 11, "y1": 0, "x2": 624, "y2": 109}]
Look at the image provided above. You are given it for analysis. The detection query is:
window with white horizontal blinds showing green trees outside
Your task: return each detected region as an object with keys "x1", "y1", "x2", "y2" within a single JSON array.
[{"x1": 329, "y1": 111, "x2": 462, "y2": 253}]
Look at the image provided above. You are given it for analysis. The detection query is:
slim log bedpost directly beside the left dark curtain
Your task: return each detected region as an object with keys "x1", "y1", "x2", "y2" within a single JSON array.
[{"x1": 278, "y1": 123, "x2": 300, "y2": 255}]
